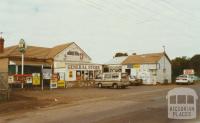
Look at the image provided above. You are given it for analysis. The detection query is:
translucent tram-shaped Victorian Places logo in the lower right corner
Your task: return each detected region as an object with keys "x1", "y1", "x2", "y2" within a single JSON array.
[{"x1": 167, "y1": 87, "x2": 198, "y2": 119}]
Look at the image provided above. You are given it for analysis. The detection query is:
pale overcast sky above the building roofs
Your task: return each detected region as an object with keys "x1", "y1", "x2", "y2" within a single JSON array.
[{"x1": 0, "y1": 0, "x2": 200, "y2": 63}]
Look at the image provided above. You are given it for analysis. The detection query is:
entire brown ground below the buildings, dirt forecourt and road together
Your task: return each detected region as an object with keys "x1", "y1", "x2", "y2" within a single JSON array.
[{"x1": 0, "y1": 83, "x2": 200, "y2": 123}]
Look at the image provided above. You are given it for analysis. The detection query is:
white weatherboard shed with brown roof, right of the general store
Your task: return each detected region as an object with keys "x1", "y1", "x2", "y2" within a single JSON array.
[{"x1": 122, "y1": 52, "x2": 172, "y2": 84}]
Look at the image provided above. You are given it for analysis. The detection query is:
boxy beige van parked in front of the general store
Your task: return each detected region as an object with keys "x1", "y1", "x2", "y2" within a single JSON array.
[{"x1": 95, "y1": 73, "x2": 129, "y2": 89}]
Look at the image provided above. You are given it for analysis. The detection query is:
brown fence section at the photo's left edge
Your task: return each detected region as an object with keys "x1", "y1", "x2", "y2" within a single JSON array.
[{"x1": 0, "y1": 73, "x2": 10, "y2": 101}]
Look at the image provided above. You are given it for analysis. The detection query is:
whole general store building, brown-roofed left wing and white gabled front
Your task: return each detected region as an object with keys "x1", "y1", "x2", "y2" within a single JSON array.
[{"x1": 0, "y1": 38, "x2": 102, "y2": 84}]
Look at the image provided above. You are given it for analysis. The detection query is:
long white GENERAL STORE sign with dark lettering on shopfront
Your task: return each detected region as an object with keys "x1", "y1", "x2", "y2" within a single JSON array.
[{"x1": 68, "y1": 65, "x2": 101, "y2": 70}]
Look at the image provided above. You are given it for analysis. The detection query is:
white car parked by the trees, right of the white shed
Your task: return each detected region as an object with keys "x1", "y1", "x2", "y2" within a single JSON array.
[{"x1": 176, "y1": 75, "x2": 195, "y2": 84}]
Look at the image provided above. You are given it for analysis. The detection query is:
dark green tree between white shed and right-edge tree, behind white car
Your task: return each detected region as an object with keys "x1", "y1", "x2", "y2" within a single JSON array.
[{"x1": 172, "y1": 56, "x2": 191, "y2": 80}]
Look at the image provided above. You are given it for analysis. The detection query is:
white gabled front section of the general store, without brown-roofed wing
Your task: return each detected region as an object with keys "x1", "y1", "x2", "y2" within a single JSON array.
[{"x1": 54, "y1": 42, "x2": 102, "y2": 81}]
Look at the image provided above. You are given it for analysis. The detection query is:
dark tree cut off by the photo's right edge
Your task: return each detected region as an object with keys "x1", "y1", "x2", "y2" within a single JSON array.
[{"x1": 190, "y1": 55, "x2": 200, "y2": 76}]
